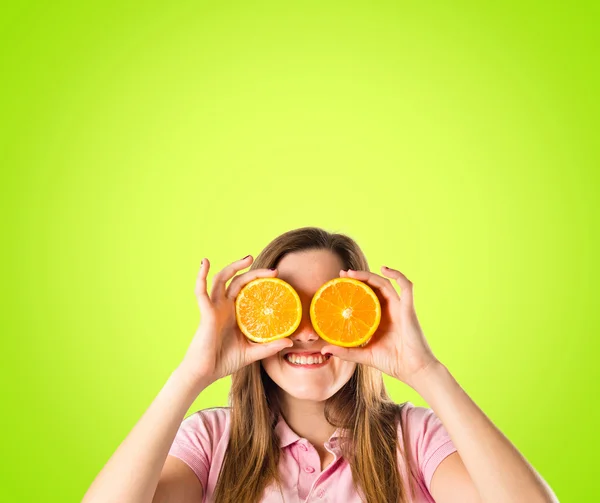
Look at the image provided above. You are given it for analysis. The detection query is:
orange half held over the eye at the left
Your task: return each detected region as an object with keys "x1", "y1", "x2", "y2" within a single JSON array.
[{"x1": 235, "y1": 278, "x2": 302, "y2": 342}]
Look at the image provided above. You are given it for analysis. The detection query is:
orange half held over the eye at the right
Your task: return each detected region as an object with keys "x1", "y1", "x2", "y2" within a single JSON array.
[{"x1": 310, "y1": 278, "x2": 381, "y2": 348}]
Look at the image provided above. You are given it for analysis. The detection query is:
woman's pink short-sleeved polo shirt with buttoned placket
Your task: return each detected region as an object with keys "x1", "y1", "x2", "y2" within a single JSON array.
[{"x1": 169, "y1": 402, "x2": 456, "y2": 503}]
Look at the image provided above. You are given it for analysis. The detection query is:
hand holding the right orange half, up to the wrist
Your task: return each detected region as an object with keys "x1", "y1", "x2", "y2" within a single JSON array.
[{"x1": 321, "y1": 267, "x2": 438, "y2": 387}]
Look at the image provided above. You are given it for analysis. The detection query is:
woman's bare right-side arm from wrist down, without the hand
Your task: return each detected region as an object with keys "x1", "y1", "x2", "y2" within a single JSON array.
[{"x1": 412, "y1": 362, "x2": 558, "y2": 503}]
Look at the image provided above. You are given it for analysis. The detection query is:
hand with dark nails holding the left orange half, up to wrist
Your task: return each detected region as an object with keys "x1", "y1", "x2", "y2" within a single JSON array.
[{"x1": 179, "y1": 255, "x2": 293, "y2": 385}]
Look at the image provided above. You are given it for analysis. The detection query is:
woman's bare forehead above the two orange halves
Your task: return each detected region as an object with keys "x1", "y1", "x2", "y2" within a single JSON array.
[{"x1": 277, "y1": 250, "x2": 344, "y2": 295}]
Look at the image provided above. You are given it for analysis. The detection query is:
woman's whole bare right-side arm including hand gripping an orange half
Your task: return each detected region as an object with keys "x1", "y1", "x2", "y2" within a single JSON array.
[{"x1": 321, "y1": 266, "x2": 558, "y2": 503}]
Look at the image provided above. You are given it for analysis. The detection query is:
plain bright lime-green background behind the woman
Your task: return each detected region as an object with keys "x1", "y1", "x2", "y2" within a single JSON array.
[{"x1": 0, "y1": 1, "x2": 600, "y2": 502}]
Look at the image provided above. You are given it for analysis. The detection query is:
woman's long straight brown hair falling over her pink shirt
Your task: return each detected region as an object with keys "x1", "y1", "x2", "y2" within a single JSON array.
[{"x1": 214, "y1": 227, "x2": 413, "y2": 503}]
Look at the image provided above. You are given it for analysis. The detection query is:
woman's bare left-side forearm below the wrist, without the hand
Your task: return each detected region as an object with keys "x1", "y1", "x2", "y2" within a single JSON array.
[{"x1": 82, "y1": 368, "x2": 209, "y2": 503}]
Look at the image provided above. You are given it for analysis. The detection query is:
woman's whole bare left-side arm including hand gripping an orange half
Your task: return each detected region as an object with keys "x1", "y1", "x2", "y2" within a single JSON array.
[{"x1": 82, "y1": 255, "x2": 292, "y2": 503}]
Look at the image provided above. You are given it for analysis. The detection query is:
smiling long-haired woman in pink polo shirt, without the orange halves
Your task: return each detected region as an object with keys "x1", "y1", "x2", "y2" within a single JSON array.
[{"x1": 83, "y1": 227, "x2": 558, "y2": 503}]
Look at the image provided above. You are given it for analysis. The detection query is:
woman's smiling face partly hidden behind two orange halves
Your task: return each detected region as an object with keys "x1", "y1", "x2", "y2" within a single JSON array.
[{"x1": 261, "y1": 250, "x2": 356, "y2": 402}]
